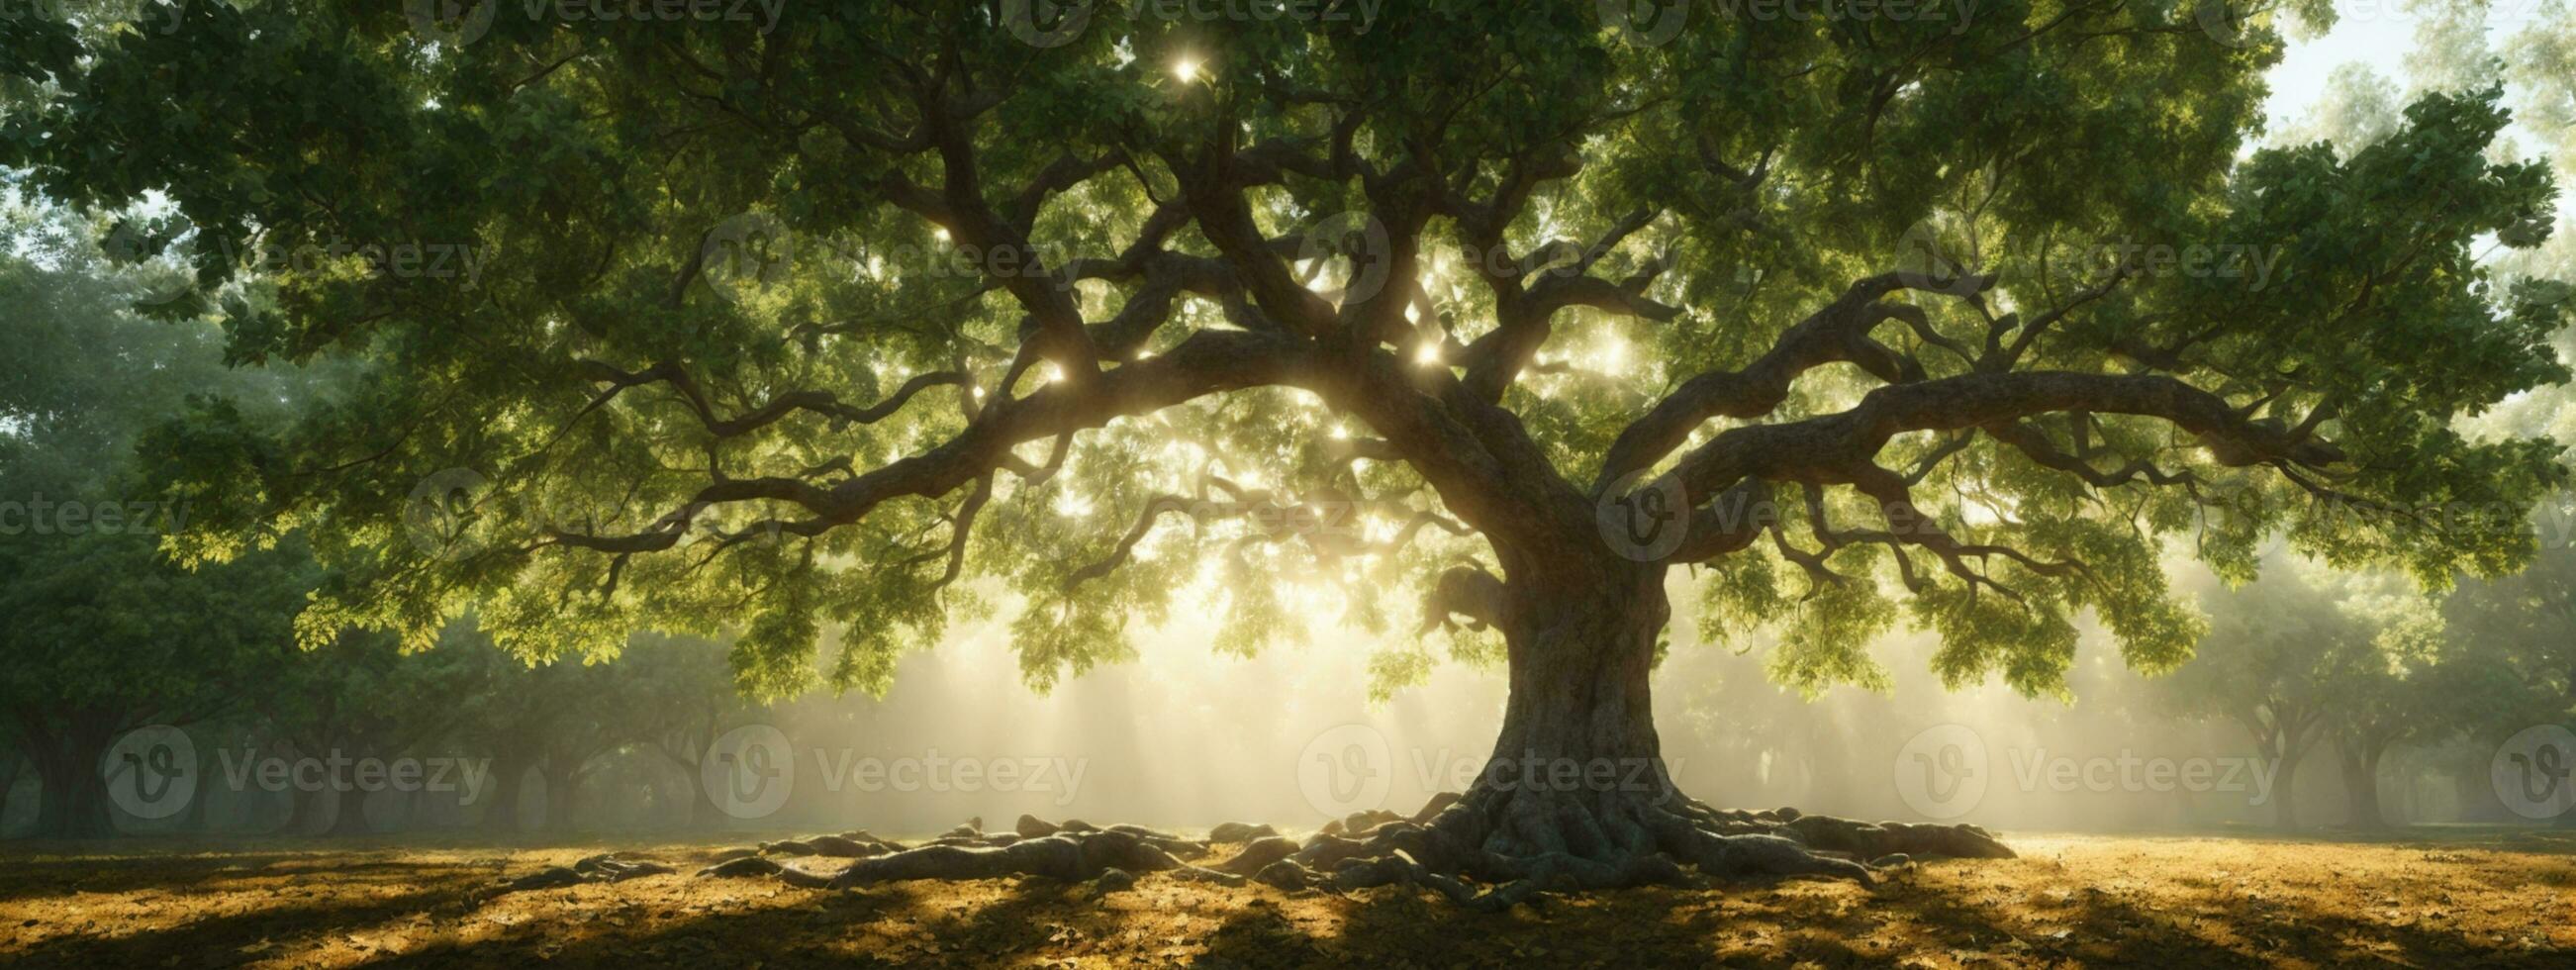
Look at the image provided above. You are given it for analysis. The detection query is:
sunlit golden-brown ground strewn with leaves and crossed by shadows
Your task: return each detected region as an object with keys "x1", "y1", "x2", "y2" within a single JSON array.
[{"x1": 0, "y1": 833, "x2": 2576, "y2": 967}]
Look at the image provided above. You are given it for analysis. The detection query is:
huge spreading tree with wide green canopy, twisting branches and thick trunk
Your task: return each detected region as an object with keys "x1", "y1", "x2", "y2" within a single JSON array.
[{"x1": 0, "y1": 0, "x2": 2568, "y2": 901}]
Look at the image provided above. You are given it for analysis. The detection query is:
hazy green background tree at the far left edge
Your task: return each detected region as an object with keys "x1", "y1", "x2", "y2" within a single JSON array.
[{"x1": 0, "y1": 193, "x2": 342, "y2": 835}]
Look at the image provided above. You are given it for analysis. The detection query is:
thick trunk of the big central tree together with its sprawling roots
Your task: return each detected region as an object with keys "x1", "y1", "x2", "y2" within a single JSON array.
[{"x1": 709, "y1": 562, "x2": 2012, "y2": 908}]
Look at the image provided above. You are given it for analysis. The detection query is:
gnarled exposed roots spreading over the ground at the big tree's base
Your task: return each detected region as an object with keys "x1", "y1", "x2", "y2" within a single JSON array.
[{"x1": 690, "y1": 790, "x2": 2012, "y2": 911}]
